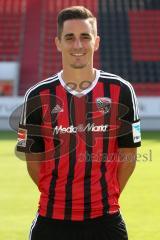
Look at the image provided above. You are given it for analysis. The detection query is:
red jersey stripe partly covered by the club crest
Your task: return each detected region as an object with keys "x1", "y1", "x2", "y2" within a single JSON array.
[{"x1": 91, "y1": 83, "x2": 104, "y2": 218}]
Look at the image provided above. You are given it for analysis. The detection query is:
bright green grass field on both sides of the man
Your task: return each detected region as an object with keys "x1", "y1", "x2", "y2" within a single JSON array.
[{"x1": 0, "y1": 132, "x2": 160, "y2": 240}]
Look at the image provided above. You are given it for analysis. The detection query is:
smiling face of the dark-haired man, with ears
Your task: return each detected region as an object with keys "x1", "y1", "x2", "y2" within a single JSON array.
[{"x1": 55, "y1": 19, "x2": 99, "y2": 69}]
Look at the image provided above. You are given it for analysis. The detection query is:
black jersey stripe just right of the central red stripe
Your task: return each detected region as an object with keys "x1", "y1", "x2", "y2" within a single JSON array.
[{"x1": 84, "y1": 92, "x2": 93, "y2": 219}]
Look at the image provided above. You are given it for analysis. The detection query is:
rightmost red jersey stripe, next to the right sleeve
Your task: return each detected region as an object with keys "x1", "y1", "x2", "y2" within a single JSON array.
[{"x1": 106, "y1": 84, "x2": 120, "y2": 212}]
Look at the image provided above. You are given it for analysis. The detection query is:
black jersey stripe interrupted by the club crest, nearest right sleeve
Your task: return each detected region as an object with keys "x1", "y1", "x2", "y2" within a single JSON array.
[{"x1": 100, "y1": 83, "x2": 110, "y2": 214}]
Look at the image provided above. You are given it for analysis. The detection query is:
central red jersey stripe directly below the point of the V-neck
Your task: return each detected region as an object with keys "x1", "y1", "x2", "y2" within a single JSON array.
[{"x1": 72, "y1": 97, "x2": 86, "y2": 220}]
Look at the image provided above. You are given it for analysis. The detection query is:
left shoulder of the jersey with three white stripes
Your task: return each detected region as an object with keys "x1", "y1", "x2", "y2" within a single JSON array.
[{"x1": 24, "y1": 73, "x2": 58, "y2": 101}]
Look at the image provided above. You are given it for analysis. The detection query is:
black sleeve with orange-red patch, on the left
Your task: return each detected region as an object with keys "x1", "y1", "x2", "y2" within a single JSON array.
[{"x1": 16, "y1": 92, "x2": 44, "y2": 153}]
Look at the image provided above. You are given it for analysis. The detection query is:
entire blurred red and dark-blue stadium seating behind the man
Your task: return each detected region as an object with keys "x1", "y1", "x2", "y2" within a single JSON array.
[{"x1": 0, "y1": 0, "x2": 160, "y2": 96}]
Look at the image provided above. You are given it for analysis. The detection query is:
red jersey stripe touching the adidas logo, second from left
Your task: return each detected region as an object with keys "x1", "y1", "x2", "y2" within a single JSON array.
[{"x1": 52, "y1": 85, "x2": 69, "y2": 219}]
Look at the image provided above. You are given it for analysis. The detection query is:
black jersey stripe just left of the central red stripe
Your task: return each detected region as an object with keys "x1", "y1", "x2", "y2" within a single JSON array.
[{"x1": 64, "y1": 93, "x2": 76, "y2": 220}]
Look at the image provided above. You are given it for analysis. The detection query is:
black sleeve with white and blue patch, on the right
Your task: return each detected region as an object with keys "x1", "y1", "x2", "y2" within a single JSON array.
[{"x1": 118, "y1": 81, "x2": 141, "y2": 148}]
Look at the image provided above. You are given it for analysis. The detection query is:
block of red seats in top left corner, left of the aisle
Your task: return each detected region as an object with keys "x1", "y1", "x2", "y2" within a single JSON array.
[{"x1": 0, "y1": 0, "x2": 25, "y2": 61}]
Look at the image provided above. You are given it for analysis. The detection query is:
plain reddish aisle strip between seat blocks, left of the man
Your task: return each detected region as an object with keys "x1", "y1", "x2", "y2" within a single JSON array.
[{"x1": 19, "y1": 0, "x2": 42, "y2": 95}]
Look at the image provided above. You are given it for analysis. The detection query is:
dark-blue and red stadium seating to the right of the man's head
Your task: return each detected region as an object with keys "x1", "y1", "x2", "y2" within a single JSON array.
[{"x1": 99, "y1": 0, "x2": 160, "y2": 95}]
